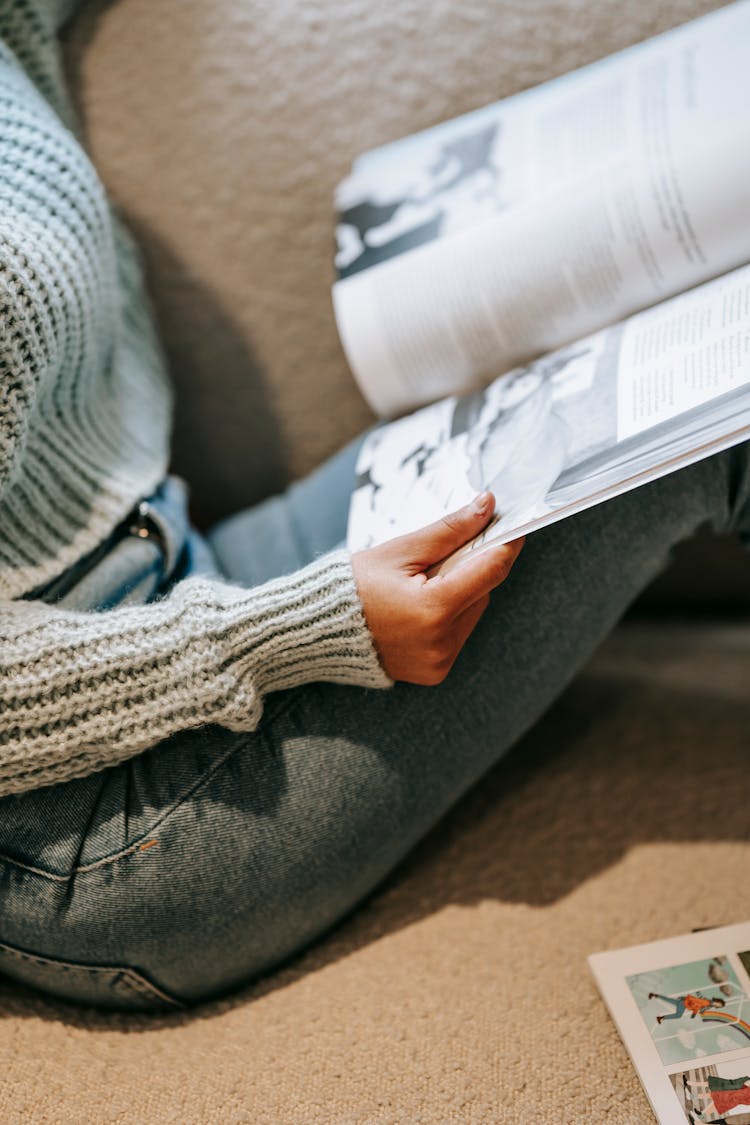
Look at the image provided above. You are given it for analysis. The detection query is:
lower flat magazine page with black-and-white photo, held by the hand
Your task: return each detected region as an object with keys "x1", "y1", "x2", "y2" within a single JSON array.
[{"x1": 347, "y1": 266, "x2": 750, "y2": 569}]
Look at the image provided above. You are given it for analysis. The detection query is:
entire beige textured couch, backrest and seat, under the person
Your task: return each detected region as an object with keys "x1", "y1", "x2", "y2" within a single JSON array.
[{"x1": 0, "y1": 0, "x2": 750, "y2": 1125}]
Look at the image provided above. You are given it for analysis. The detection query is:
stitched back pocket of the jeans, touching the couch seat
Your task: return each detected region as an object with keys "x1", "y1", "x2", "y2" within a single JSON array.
[{"x1": 0, "y1": 943, "x2": 186, "y2": 1013}]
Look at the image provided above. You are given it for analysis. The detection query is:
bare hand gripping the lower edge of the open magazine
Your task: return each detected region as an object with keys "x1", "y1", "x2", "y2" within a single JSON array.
[{"x1": 352, "y1": 493, "x2": 524, "y2": 685}]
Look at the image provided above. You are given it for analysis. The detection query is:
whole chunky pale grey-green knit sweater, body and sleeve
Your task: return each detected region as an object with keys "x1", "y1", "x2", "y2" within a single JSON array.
[{"x1": 0, "y1": 0, "x2": 390, "y2": 795}]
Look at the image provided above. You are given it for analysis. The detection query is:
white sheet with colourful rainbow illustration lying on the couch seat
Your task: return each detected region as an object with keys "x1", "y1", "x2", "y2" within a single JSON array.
[{"x1": 588, "y1": 923, "x2": 750, "y2": 1125}]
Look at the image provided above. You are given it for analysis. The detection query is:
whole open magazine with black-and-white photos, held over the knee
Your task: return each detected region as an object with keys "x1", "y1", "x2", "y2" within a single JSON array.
[{"x1": 334, "y1": 0, "x2": 750, "y2": 562}]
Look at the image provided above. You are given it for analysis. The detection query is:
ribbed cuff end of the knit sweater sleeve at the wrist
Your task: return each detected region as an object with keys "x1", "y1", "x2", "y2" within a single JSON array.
[{"x1": 220, "y1": 549, "x2": 392, "y2": 695}]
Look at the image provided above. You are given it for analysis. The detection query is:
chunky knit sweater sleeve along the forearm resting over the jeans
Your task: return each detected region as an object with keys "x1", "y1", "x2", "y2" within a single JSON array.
[{"x1": 0, "y1": 550, "x2": 390, "y2": 795}]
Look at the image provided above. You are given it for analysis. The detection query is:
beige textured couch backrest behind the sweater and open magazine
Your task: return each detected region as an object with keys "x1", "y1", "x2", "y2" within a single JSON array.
[{"x1": 60, "y1": 0, "x2": 733, "y2": 514}]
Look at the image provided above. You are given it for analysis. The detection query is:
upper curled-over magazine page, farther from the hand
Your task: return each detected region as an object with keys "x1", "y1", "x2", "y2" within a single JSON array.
[{"x1": 334, "y1": 0, "x2": 750, "y2": 416}]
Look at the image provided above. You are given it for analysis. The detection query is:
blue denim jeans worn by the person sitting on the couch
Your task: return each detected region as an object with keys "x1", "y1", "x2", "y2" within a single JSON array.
[{"x1": 0, "y1": 446, "x2": 750, "y2": 1009}]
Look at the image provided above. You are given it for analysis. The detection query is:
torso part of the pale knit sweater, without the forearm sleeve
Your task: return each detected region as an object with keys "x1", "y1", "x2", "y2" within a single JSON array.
[{"x1": 0, "y1": 0, "x2": 170, "y2": 597}]
